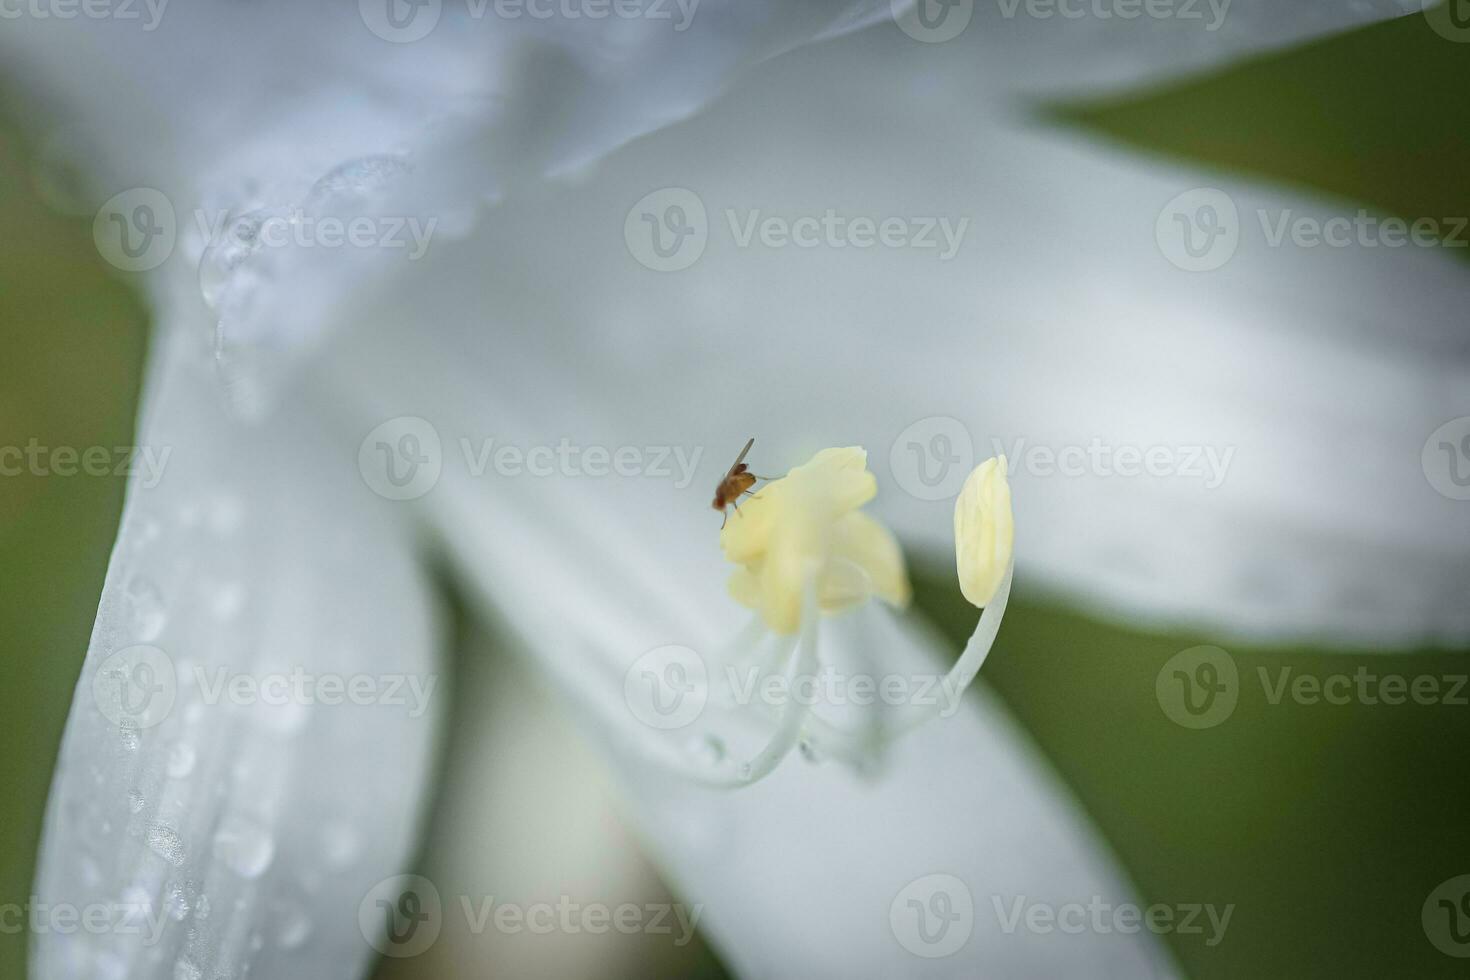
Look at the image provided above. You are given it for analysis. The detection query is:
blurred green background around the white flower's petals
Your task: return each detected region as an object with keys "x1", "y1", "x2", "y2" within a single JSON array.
[{"x1": 0, "y1": 18, "x2": 1470, "y2": 979}]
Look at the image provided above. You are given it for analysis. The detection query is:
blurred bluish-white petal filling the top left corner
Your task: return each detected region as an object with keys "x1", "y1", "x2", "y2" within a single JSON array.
[{"x1": 0, "y1": 0, "x2": 888, "y2": 414}]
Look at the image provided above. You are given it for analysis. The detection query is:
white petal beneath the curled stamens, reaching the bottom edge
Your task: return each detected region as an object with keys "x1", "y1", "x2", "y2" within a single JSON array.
[{"x1": 331, "y1": 294, "x2": 1169, "y2": 976}]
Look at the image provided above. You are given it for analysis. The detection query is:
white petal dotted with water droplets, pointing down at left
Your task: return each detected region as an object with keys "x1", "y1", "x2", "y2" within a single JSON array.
[{"x1": 31, "y1": 332, "x2": 442, "y2": 980}]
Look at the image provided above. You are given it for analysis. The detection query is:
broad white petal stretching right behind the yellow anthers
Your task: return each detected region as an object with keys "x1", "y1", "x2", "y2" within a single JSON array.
[{"x1": 316, "y1": 19, "x2": 1470, "y2": 648}]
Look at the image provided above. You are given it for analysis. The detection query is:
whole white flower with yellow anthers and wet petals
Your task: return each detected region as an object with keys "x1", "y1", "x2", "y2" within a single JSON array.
[{"x1": 0, "y1": 0, "x2": 1446, "y2": 980}]
